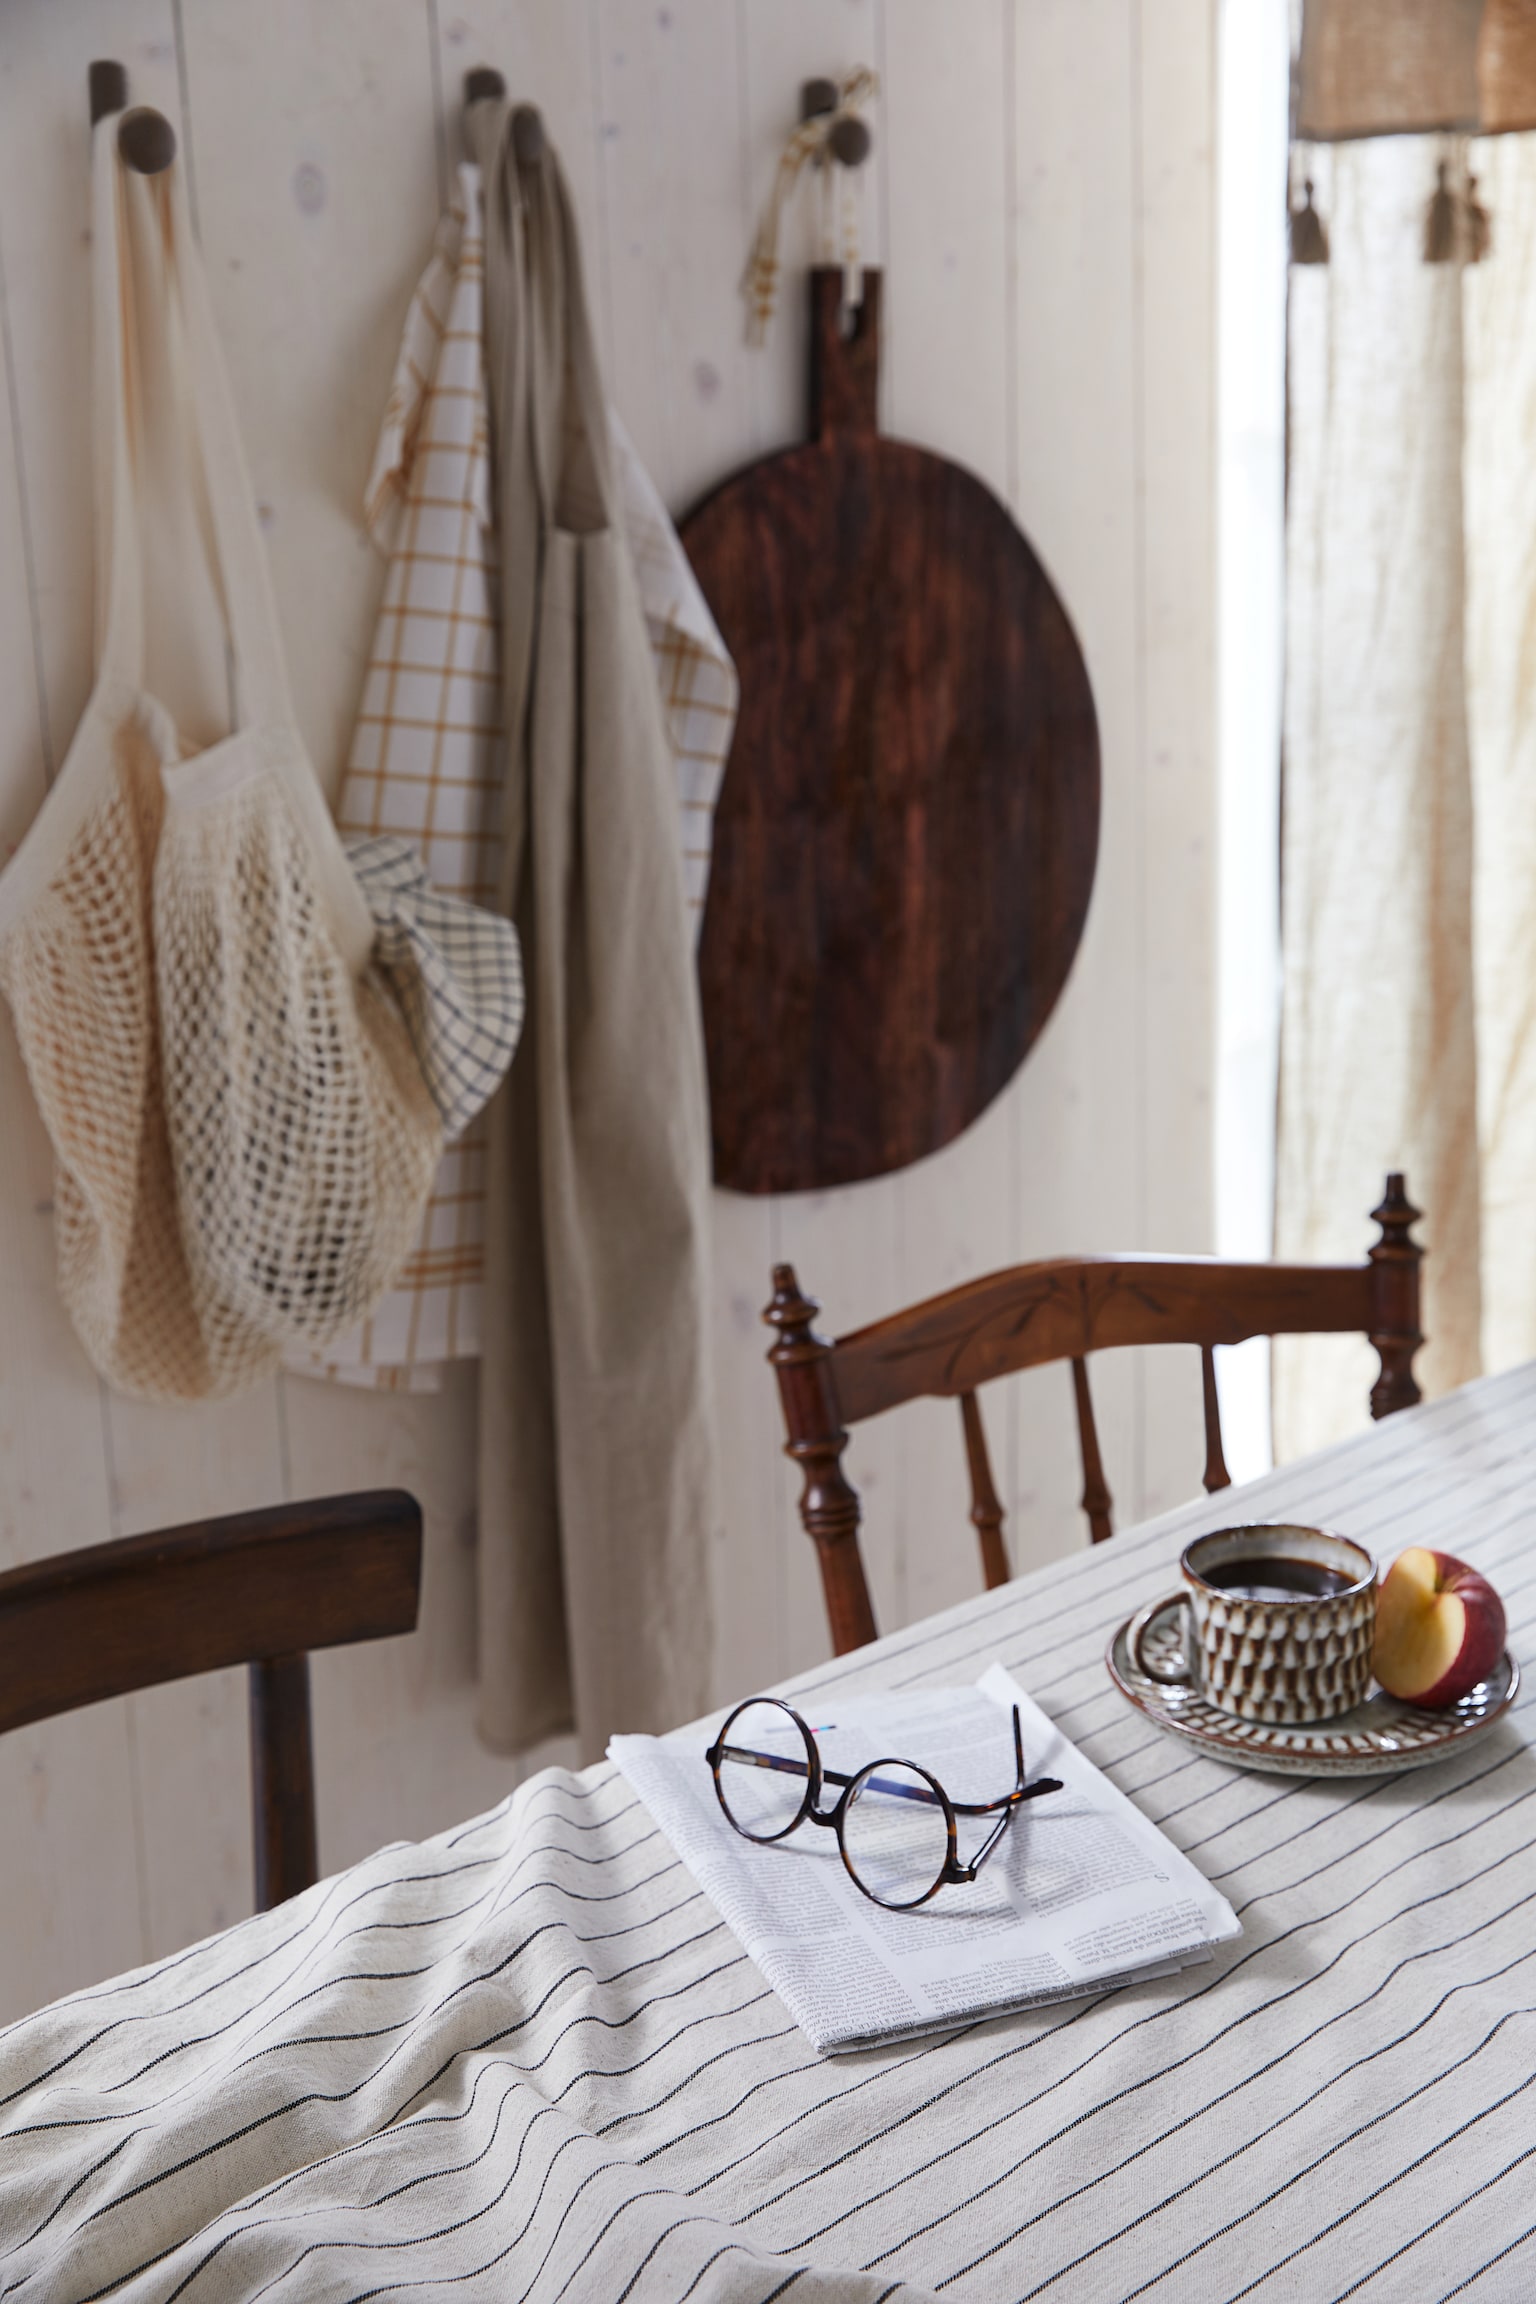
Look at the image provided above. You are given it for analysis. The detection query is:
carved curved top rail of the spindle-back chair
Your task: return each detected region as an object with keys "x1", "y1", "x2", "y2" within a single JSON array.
[{"x1": 831, "y1": 1256, "x2": 1375, "y2": 1424}]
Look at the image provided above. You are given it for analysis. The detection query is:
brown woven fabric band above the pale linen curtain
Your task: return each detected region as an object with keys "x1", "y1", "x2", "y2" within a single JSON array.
[{"x1": 1297, "y1": 0, "x2": 1536, "y2": 143}]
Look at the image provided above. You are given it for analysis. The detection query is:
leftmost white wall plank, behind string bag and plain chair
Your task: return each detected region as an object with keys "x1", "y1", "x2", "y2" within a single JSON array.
[{"x1": 0, "y1": 0, "x2": 177, "y2": 2016}]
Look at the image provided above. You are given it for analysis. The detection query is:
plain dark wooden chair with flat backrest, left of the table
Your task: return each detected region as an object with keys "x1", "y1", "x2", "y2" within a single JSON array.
[{"x1": 0, "y1": 1488, "x2": 421, "y2": 1912}]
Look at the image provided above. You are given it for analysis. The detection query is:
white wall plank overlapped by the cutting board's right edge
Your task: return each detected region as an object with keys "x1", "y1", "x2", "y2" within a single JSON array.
[{"x1": 1013, "y1": 0, "x2": 1142, "y2": 1567}]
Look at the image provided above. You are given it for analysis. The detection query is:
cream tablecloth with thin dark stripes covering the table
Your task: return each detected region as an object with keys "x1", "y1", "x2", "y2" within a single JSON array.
[{"x1": 0, "y1": 1366, "x2": 1536, "y2": 2304}]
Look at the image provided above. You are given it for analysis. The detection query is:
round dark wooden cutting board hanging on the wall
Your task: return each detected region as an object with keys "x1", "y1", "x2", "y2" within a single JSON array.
[{"x1": 682, "y1": 270, "x2": 1098, "y2": 1191}]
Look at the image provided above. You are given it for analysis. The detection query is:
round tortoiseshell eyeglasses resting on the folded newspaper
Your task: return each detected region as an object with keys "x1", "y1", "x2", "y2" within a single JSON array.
[{"x1": 705, "y1": 1696, "x2": 1062, "y2": 1912}]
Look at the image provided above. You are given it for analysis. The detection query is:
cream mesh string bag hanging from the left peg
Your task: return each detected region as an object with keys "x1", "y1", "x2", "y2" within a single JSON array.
[{"x1": 0, "y1": 120, "x2": 442, "y2": 1401}]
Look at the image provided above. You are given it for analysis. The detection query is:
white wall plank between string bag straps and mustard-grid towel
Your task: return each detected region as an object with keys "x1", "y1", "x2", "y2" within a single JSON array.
[{"x1": 182, "y1": 0, "x2": 438, "y2": 793}]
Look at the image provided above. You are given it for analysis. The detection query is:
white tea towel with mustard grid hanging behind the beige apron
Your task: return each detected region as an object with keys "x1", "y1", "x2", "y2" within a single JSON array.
[{"x1": 290, "y1": 164, "x2": 737, "y2": 1392}]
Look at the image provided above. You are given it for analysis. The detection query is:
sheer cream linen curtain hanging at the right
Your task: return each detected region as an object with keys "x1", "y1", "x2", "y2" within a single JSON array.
[{"x1": 1273, "y1": 134, "x2": 1536, "y2": 1456}]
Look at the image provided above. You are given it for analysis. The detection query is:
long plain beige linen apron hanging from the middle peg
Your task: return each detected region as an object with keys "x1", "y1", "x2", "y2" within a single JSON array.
[{"x1": 470, "y1": 104, "x2": 714, "y2": 1758}]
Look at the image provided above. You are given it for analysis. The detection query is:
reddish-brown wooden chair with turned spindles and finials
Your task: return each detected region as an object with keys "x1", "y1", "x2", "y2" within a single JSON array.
[{"x1": 762, "y1": 1175, "x2": 1423, "y2": 1654}]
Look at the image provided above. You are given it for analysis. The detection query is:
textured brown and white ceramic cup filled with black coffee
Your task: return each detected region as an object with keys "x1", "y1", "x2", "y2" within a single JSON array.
[{"x1": 1128, "y1": 1525, "x2": 1377, "y2": 1728}]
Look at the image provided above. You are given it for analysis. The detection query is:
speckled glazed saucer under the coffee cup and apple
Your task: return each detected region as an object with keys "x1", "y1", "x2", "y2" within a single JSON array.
[{"x1": 1103, "y1": 1597, "x2": 1520, "y2": 1776}]
